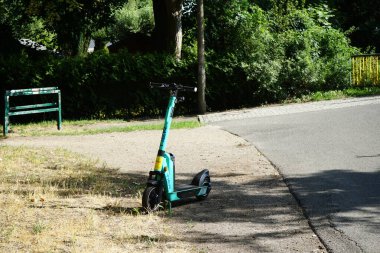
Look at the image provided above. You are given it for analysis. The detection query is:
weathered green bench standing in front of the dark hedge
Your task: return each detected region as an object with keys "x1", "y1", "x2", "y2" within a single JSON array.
[{"x1": 3, "y1": 87, "x2": 62, "y2": 136}]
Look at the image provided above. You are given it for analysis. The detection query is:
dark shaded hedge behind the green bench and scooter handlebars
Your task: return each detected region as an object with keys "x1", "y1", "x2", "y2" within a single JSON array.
[{"x1": 0, "y1": 51, "x2": 196, "y2": 119}]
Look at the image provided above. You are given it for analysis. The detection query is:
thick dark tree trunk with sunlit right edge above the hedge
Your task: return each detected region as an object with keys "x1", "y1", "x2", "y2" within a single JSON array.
[{"x1": 153, "y1": 0, "x2": 183, "y2": 59}]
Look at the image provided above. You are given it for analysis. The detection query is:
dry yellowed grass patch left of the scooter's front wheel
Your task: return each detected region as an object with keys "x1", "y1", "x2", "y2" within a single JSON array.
[{"x1": 0, "y1": 145, "x2": 194, "y2": 252}]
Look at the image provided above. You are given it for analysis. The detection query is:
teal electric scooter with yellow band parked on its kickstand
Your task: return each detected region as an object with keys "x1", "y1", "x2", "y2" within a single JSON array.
[{"x1": 142, "y1": 83, "x2": 211, "y2": 212}]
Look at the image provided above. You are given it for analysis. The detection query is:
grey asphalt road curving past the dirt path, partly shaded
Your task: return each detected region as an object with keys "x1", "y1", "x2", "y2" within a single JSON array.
[{"x1": 212, "y1": 103, "x2": 380, "y2": 252}]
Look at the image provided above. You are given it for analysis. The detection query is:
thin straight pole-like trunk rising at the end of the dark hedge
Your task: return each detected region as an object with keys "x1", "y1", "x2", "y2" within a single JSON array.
[{"x1": 197, "y1": 0, "x2": 207, "y2": 114}]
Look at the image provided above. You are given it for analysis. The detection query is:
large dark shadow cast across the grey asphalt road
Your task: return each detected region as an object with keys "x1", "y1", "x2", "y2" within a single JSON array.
[{"x1": 286, "y1": 168, "x2": 380, "y2": 228}]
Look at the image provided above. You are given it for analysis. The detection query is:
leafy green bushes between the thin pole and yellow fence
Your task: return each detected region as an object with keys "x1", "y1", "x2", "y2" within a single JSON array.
[{"x1": 197, "y1": 0, "x2": 357, "y2": 109}]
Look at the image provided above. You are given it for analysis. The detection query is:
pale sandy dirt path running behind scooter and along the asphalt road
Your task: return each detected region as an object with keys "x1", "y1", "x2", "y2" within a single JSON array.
[{"x1": 3, "y1": 126, "x2": 326, "y2": 252}]
